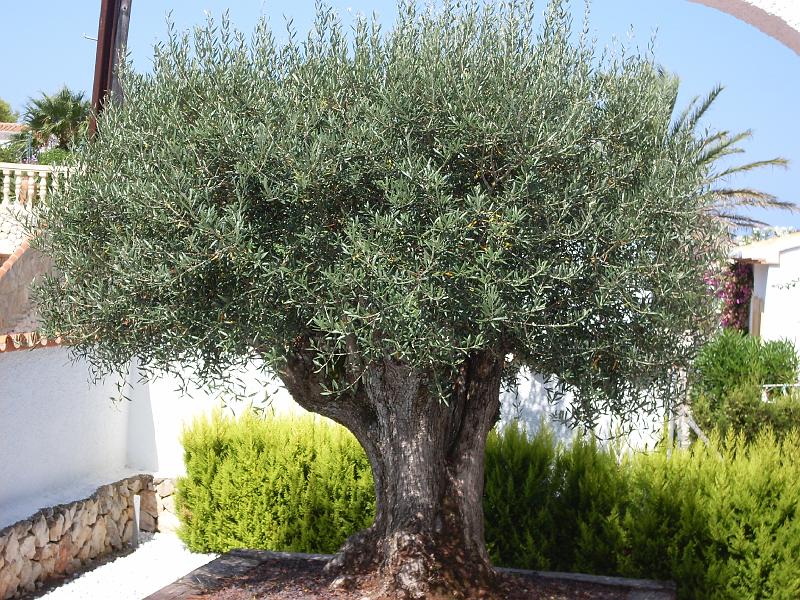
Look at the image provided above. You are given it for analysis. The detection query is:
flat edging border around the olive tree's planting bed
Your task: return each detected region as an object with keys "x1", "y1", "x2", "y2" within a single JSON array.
[{"x1": 144, "y1": 549, "x2": 675, "y2": 600}]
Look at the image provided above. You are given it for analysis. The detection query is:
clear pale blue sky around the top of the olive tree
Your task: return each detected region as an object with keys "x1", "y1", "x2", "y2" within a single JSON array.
[{"x1": 0, "y1": 0, "x2": 800, "y2": 228}]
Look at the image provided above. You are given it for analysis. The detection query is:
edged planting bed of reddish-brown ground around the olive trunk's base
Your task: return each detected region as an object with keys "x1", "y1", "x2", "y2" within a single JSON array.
[{"x1": 146, "y1": 550, "x2": 675, "y2": 600}]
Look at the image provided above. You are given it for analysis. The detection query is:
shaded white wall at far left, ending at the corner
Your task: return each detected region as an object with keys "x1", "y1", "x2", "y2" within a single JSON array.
[{"x1": 0, "y1": 347, "x2": 128, "y2": 527}]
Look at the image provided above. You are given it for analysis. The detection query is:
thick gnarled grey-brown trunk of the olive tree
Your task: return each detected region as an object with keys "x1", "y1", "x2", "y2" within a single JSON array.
[{"x1": 281, "y1": 353, "x2": 502, "y2": 598}]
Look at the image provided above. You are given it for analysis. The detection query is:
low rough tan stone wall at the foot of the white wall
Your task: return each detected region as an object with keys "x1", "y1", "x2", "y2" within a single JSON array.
[{"x1": 0, "y1": 475, "x2": 177, "y2": 600}]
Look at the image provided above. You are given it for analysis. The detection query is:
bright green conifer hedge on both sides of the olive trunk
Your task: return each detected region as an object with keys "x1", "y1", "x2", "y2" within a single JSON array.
[{"x1": 178, "y1": 415, "x2": 800, "y2": 599}]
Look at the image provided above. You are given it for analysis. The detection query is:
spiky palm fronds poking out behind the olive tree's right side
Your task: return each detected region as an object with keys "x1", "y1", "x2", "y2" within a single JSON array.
[{"x1": 672, "y1": 82, "x2": 799, "y2": 233}]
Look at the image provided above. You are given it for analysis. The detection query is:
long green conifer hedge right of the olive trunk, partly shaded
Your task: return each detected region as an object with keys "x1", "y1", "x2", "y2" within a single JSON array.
[{"x1": 484, "y1": 428, "x2": 800, "y2": 599}]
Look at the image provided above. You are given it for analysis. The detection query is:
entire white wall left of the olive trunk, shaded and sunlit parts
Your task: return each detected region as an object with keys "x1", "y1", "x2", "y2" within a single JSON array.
[{"x1": 0, "y1": 347, "x2": 302, "y2": 528}]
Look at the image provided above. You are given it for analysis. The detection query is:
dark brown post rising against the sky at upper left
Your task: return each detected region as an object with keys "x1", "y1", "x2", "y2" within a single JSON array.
[{"x1": 89, "y1": 0, "x2": 133, "y2": 135}]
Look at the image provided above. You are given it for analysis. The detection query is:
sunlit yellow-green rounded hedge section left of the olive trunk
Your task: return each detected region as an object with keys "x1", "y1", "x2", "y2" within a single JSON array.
[{"x1": 177, "y1": 414, "x2": 374, "y2": 552}]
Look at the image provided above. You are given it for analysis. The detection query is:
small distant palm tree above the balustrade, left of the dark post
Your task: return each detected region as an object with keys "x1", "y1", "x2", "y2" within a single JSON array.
[{"x1": 23, "y1": 86, "x2": 91, "y2": 150}]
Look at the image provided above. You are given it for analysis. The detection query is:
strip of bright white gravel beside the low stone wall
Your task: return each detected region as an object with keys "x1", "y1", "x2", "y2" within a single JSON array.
[{"x1": 41, "y1": 533, "x2": 218, "y2": 600}]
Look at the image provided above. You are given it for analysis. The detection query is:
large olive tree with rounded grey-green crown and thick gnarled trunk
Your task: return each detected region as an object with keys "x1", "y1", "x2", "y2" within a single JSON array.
[{"x1": 37, "y1": 1, "x2": 720, "y2": 598}]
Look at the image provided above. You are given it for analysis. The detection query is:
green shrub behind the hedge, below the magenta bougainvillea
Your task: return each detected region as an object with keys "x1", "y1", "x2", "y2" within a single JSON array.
[{"x1": 691, "y1": 330, "x2": 800, "y2": 439}]
